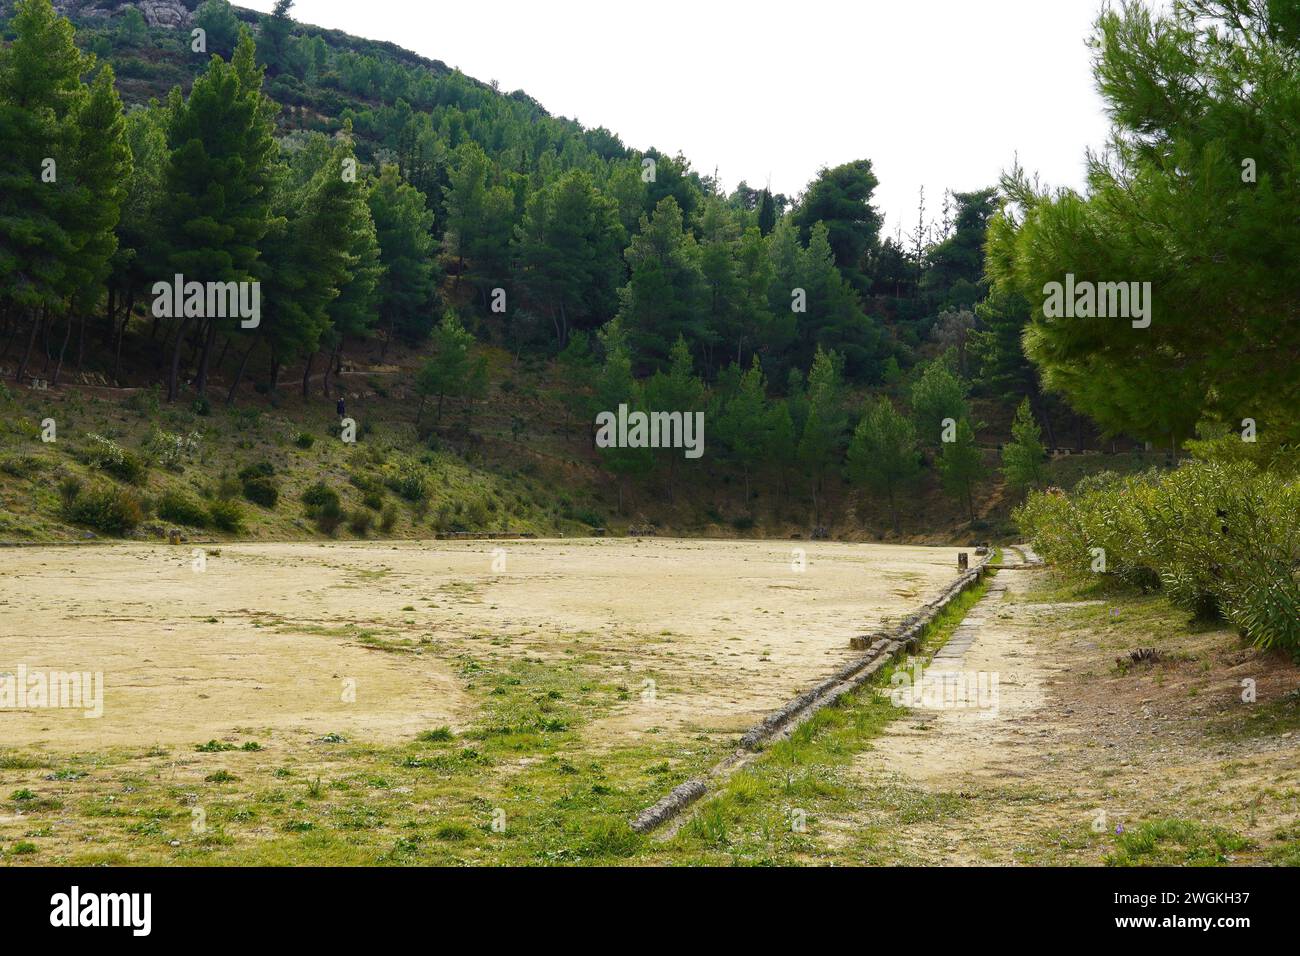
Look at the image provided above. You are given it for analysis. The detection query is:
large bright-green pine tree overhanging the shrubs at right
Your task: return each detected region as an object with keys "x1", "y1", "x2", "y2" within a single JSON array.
[{"x1": 987, "y1": 0, "x2": 1300, "y2": 449}]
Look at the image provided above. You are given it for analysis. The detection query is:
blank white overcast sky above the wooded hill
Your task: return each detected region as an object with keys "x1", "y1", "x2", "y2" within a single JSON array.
[{"x1": 237, "y1": 0, "x2": 1123, "y2": 234}]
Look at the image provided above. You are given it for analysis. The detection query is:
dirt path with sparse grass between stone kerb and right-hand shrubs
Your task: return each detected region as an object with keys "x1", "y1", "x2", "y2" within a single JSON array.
[{"x1": 827, "y1": 571, "x2": 1300, "y2": 865}]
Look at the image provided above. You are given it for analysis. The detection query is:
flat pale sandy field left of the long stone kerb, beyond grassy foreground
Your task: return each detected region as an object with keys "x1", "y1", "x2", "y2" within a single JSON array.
[{"x1": 0, "y1": 540, "x2": 957, "y2": 750}]
